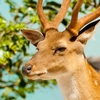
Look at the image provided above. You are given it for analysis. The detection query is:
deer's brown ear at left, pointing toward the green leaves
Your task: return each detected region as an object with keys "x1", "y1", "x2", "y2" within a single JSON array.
[{"x1": 21, "y1": 29, "x2": 44, "y2": 45}]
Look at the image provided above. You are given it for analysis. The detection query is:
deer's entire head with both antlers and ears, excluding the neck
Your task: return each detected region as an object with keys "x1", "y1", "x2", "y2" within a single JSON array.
[{"x1": 22, "y1": 0, "x2": 100, "y2": 80}]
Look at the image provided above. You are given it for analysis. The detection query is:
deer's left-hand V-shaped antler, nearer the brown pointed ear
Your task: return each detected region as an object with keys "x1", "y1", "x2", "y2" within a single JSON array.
[{"x1": 37, "y1": 0, "x2": 71, "y2": 31}]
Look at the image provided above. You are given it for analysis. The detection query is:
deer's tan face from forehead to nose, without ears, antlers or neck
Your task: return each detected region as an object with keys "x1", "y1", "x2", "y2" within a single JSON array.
[{"x1": 23, "y1": 30, "x2": 74, "y2": 80}]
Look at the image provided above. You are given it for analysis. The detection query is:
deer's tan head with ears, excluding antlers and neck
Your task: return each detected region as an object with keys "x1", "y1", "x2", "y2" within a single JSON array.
[{"x1": 22, "y1": 25, "x2": 97, "y2": 80}]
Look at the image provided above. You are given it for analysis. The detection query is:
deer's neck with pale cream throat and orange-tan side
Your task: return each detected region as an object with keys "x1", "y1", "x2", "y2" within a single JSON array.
[{"x1": 57, "y1": 55, "x2": 100, "y2": 100}]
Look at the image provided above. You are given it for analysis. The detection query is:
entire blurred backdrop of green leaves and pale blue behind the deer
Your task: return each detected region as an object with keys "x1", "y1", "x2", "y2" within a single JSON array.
[{"x1": 0, "y1": 0, "x2": 100, "y2": 100}]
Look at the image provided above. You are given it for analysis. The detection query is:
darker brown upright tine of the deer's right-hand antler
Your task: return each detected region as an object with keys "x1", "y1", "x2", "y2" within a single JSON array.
[{"x1": 67, "y1": 0, "x2": 84, "y2": 35}]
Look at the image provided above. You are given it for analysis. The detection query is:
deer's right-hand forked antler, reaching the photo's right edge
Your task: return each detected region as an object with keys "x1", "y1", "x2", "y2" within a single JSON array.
[{"x1": 67, "y1": 0, "x2": 100, "y2": 36}]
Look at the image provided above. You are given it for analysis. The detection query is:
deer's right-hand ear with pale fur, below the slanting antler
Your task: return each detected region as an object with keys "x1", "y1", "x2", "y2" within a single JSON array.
[{"x1": 77, "y1": 22, "x2": 100, "y2": 44}]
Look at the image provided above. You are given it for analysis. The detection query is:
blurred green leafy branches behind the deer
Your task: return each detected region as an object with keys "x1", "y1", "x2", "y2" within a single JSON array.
[{"x1": 0, "y1": 0, "x2": 100, "y2": 100}]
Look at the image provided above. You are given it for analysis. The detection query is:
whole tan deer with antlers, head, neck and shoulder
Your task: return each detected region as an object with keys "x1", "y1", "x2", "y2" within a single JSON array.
[{"x1": 21, "y1": 0, "x2": 100, "y2": 100}]
